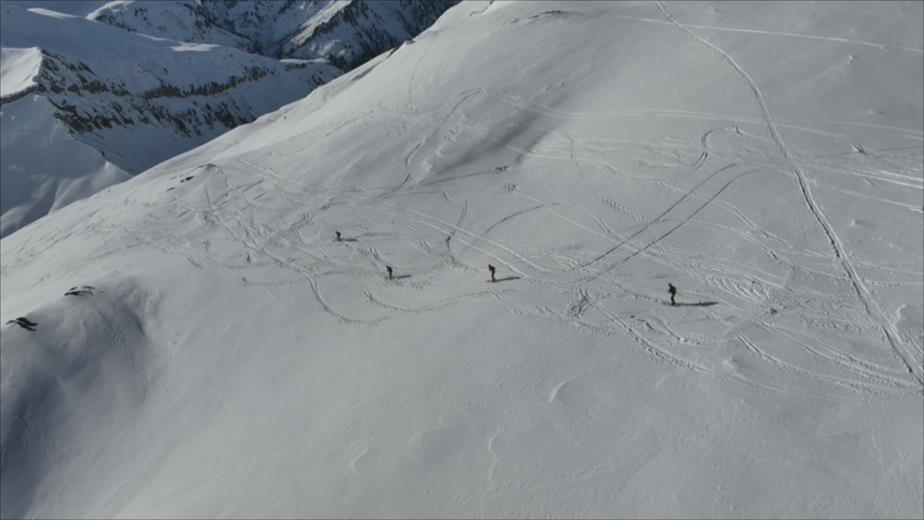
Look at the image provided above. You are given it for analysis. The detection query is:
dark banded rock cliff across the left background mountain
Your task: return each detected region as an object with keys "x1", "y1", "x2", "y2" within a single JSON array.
[{"x1": 8, "y1": 42, "x2": 340, "y2": 173}]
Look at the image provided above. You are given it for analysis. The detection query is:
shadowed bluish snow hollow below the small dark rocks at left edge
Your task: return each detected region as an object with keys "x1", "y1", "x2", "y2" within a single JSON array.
[{"x1": 0, "y1": 279, "x2": 158, "y2": 518}]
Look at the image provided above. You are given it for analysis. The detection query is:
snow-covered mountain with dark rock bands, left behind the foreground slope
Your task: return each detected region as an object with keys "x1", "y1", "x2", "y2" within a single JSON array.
[{"x1": 0, "y1": 3, "x2": 340, "y2": 239}]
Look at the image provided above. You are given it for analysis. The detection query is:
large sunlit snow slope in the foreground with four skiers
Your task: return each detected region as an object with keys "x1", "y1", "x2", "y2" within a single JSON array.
[{"x1": 0, "y1": 2, "x2": 924, "y2": 518}]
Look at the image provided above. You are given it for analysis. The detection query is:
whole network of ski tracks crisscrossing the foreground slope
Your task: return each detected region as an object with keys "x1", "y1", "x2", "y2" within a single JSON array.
[{"x1": 5, "y1": 3, "x2": 912, "y2": 426}]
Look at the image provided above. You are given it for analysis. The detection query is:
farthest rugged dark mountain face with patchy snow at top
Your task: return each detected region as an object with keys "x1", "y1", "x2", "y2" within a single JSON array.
[{"x1": 88, "y1": 0, "x2": 456, "y2": 70}]
